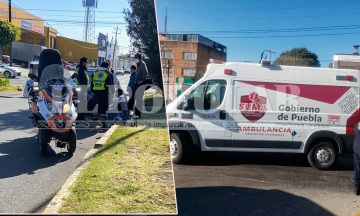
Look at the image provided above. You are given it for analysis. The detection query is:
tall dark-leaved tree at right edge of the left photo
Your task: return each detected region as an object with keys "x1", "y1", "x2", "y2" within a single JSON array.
[{"x1": 123, "y1": 0, "x2": 163, "y2": 89}]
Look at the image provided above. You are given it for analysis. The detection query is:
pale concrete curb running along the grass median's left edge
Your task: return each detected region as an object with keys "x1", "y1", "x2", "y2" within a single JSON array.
[{"x1": 42, "y1": 125, "x2": 118, "y2": 214}]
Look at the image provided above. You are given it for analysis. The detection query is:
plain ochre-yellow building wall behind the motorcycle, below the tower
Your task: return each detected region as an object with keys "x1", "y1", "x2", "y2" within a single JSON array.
[{"x1": 56, "y1": 36, "x2": 98, "y2": 62}]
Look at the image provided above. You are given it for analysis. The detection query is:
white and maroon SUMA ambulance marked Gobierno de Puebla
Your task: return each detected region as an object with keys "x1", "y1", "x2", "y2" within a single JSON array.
[{"x1": 167, "y1": 60, "x2": 360, "y2": 169}]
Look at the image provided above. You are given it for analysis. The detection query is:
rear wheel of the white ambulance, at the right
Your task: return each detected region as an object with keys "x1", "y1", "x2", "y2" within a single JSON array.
[{"x1": 307, "y1": 142, "x2": 337, "y2": 170}]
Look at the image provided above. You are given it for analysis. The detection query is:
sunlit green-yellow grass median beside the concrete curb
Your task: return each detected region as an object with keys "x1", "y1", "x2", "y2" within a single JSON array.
[{"x1": 60, "y1": 127, "x2": 176, "y2": 214}]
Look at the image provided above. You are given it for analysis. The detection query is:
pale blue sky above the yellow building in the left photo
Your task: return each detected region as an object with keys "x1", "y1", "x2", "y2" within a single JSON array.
[{"x1": 5, "y1": 0, "x2": 131, "y2": 53}]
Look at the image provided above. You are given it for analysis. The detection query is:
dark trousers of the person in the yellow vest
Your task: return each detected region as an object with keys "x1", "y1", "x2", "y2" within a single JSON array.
[{"x1": 89, "y1": 91, "x2": 109, "y2": 121}]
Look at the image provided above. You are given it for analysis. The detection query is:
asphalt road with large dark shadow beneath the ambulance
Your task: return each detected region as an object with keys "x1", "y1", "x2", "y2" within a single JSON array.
[{"x1": 174, "y1": 152, "x2": 360, "y2": 216}]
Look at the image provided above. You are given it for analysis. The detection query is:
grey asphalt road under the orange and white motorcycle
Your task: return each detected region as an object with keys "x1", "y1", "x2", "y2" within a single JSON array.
[{"x1": 0, "y1": 72, "x2": 129, "y2": 213}]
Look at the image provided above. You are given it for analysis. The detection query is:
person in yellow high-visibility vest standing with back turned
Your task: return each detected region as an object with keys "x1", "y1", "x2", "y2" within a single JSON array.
[{"x1": 90, "y1": 61, "x2": 115, "y2": 127}]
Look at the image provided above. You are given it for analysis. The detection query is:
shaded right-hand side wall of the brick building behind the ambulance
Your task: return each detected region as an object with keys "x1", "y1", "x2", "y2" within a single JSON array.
[{"x1": 195, "y1": 43, "x2": 226, "y2": 79}]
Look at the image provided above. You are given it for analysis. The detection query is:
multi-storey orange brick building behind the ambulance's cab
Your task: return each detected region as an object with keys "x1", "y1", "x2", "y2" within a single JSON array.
[{"x1": 159, "y1": 33, "x2": 227, "y2": 99}]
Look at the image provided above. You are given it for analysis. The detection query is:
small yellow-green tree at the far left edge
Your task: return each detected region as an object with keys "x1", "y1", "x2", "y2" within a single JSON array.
[{"x1": 0, "y1": 20, "x2": 21, "y2": 60}]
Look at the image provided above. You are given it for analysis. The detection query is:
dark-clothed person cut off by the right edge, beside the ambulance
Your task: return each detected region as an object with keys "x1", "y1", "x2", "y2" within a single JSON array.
[{"x1": 353, "y1": 121, "x2": 360, "y2": 195}]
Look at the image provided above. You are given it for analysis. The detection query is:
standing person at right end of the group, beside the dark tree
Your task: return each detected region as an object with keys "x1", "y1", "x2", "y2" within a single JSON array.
[{"x1": 133, "y1": 53, "x2": 148, "y2": 118}]
